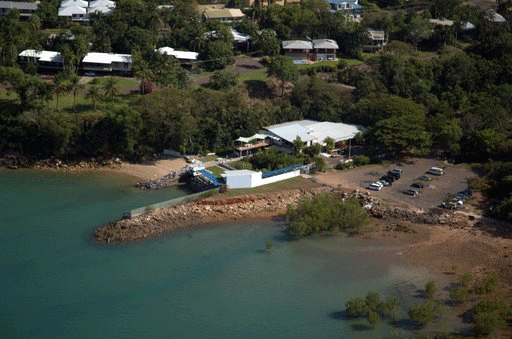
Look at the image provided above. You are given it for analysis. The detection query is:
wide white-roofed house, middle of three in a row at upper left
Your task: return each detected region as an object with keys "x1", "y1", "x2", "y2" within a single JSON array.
[{"x1": 81, "y1": 52, "x2": 132, "y2": 74}]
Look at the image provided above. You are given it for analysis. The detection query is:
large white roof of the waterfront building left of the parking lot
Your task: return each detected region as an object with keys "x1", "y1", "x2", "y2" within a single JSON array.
[{"x1": 265, "y1": 120, "x2": 364, "y2": 145}]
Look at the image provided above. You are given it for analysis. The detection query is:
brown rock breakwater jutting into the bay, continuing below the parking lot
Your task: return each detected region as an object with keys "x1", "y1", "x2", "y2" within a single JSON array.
[{"x1": 93, "y1": 187, "x2": 476, "y2": 244}]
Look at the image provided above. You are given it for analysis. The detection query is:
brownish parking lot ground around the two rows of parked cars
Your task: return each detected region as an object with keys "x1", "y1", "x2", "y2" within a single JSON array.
[{"x1": 315, "y1": 159, "x2": 475, "y2": 208}]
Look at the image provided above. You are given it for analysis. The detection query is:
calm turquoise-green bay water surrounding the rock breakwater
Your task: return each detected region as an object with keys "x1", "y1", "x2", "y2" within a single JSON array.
[{"x1": 0, "y1": 171, "x2": 424, "y2": 338}]
